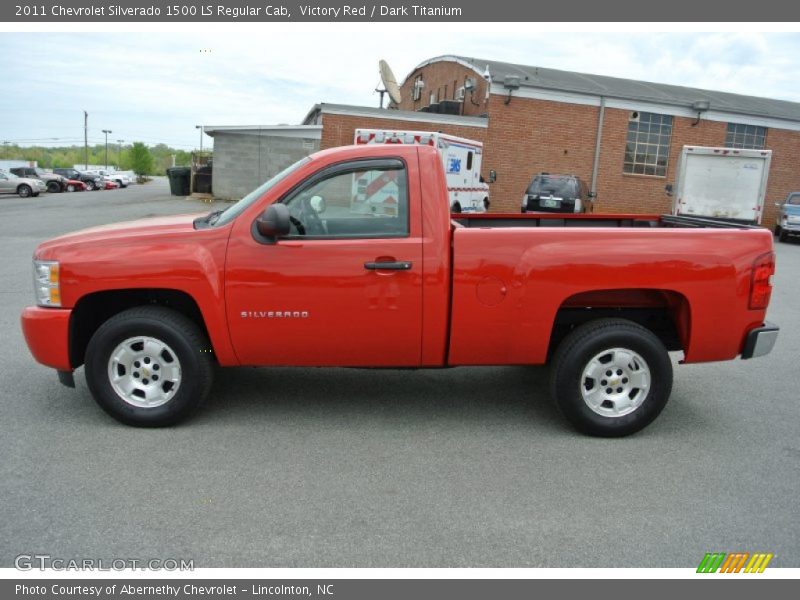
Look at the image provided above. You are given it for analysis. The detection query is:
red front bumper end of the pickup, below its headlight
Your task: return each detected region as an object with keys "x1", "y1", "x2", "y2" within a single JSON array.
[{"x1": 21, "y1": 306, "x2": 72, "y2": 371}]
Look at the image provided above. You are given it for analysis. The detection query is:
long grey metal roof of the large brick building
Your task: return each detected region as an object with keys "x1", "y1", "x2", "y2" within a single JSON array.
[{"x1": 414, "y1": 56, "x2": 800, "y2": 122}]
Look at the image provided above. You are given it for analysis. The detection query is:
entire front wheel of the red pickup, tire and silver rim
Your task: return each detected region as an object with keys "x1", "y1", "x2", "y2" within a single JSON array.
[{"x1": 86, "y1": 306, "x2": 213, "y2": 427}]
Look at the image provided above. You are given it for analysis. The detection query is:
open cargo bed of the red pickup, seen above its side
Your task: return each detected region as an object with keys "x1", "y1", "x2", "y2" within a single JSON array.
[{"x1": 453, "y1": 213, "x2": 758, "y2": 229}]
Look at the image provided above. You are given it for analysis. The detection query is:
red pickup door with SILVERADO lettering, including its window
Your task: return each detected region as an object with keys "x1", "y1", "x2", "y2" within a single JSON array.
[{"x1": 226, "y1": 158, "x2": 423, "y2": 366}]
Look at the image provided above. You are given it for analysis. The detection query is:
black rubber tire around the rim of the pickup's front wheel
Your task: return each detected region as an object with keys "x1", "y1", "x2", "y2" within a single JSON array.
[{"x1": 85, "y1": 306, "x2": 214, "y2": 427}]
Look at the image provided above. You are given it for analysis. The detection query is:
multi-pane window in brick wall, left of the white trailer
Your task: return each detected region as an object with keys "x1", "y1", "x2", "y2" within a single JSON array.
[{"x1": 623, "y1": 111, "x2": 672, "y2": 177}]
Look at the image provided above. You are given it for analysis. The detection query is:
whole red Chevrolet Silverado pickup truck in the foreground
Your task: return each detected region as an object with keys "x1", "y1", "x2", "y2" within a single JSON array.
[{"x1": 22, "y1": 145, "x2": 778, "y2": 436}]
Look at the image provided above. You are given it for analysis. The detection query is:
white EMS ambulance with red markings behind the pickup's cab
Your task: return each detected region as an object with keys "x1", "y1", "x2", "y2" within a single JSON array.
[{"x1": 354, "y1": 129, "x2": 489, "y2": 213}]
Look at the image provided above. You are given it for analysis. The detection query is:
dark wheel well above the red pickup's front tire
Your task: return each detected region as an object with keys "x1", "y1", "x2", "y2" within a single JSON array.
[{"x1": 69, "y1": 289, "x2": 208, "y2": 367}]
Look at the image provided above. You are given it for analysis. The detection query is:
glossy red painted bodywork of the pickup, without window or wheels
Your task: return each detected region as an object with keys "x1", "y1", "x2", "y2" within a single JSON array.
[{"x1": 23, "y1": 145, "x2": 772, "y2": 369}]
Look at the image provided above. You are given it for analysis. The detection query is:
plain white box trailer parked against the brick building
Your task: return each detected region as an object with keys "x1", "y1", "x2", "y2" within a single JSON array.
[{"x1": 672, "y1": 146, "x2": 772, "y2": 224}]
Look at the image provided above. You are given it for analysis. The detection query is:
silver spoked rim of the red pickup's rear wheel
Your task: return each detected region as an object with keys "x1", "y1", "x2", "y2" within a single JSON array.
[{"x1": 580, "y1": 348, "x2": 651, "y2": 418}]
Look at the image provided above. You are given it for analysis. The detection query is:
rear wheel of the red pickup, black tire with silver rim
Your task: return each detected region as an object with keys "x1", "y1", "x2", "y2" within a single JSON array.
[{"x1": 550, "y1": 319, "x2": 672, "y2": 437}]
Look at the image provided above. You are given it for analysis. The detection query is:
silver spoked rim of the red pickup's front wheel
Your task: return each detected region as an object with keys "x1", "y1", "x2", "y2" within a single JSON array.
[{"x1": 108, "y1": 336, "x2": 181, "y2": 408}]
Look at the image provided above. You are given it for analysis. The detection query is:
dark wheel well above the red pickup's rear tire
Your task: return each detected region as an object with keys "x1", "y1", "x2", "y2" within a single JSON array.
[{"x1": 548, "y1": 289, "x2": 691, "y2": 358}]
